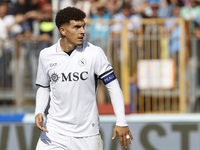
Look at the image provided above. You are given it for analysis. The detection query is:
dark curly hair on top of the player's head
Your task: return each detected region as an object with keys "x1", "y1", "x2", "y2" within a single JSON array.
[{"x1": 55, "y1": 7, "x2": 86, "y2": 29}]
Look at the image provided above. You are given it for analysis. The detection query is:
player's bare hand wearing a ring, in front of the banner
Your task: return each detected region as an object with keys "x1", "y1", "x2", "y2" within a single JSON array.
[{"x1": 112, "y1": 126, "x2": 133, "y2": 148}]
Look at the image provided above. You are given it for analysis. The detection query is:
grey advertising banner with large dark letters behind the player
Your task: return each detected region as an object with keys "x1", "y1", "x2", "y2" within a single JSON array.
[{"x1": 0, "y1": 114, "x2": 200, "y2": 150}]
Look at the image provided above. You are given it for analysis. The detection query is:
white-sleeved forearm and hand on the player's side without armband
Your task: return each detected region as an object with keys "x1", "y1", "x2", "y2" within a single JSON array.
[{"x1": 35, "y1": 87, "x2": 49, "y2": 132}]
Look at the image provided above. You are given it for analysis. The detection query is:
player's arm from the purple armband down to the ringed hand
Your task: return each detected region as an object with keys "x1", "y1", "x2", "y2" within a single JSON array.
[{"x1": 102, "y1": 72, "x2": 133, "y2": 148}]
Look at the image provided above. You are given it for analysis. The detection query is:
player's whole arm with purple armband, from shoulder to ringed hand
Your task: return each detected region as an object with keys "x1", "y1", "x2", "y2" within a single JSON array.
[{"x1": 94, "y1": 48, "x2": 133, "y2": 147}]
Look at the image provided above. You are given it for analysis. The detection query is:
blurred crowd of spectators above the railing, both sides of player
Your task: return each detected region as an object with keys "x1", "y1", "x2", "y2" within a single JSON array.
[{"x1": 0, "y1": 0, "x2": 200, "y2": 45}]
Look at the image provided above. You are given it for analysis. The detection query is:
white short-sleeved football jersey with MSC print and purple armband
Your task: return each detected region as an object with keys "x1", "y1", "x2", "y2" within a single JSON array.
[{"x1": 36, "y1": 40, "x2": 116, "y2": 137}]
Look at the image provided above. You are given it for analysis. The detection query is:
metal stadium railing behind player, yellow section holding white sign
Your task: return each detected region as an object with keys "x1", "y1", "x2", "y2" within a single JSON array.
[{"x1": 0, "y1": 19, "x2": 196, "y2": 114}]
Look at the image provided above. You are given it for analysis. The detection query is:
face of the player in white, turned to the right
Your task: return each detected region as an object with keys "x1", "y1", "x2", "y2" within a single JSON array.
[{"x1": 61, "y1": 20, "x2": 86, "y2": 46}]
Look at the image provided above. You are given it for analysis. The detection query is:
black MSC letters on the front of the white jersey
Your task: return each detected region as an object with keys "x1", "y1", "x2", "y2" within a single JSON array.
[{"x1": 61, "y1": 71, "x2": 88, "y2": 82}]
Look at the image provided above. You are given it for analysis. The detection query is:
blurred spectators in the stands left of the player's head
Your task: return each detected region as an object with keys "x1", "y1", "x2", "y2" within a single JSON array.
[{"x1": 0, "y1": 0, "x2": 54, "y2": 45}]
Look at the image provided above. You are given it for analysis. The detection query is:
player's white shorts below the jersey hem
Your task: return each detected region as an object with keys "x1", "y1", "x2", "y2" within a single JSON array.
[{"x1": 36, "y1": 131, "x2": 103, "y2": 150}]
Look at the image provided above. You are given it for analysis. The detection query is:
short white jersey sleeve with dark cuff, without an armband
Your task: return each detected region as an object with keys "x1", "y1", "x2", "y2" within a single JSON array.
[{"x1": 36, "y1": 52, "x2": 50, "y2": 87}]
